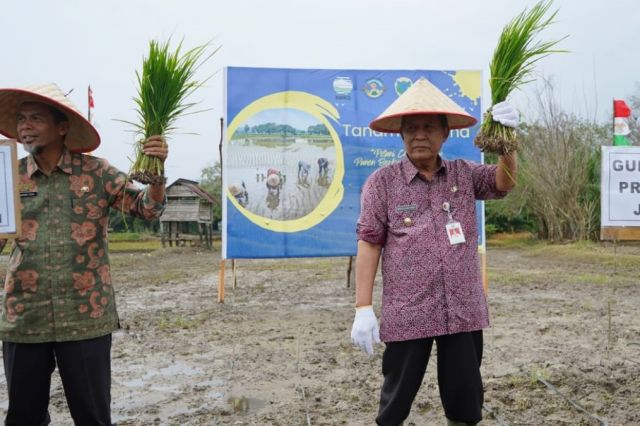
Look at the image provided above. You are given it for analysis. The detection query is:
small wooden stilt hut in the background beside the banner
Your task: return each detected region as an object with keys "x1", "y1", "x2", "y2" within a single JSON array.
[{"x1": 160, "y1": 178, "x2": 220, "y2": 248}]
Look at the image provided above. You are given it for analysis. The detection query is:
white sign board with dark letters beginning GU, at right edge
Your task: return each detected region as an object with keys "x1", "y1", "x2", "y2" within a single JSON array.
[{"x1": 600, "y1": 146, "x2": 640, "y2": 227}]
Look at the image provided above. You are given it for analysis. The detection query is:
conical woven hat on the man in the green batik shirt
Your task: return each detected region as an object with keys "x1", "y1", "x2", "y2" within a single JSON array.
[{"x1": 0, "y1": 83, "x2": 100, "y2": 152}]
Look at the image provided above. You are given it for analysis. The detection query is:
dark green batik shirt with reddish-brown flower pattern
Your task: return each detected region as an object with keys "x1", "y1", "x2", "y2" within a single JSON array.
[{"x1": 0, "y1": 151, "x2": 166, "y2": 343}]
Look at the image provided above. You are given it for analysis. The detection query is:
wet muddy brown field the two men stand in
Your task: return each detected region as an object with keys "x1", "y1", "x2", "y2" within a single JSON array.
[{"x1": 0, "y1": 238, "x2": 640, "y2": 425}]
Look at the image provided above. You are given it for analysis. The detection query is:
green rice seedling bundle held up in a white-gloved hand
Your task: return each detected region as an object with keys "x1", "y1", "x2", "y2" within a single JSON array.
[{"x1": 474, "y1": 1, "x2": 567, "y2": 154}]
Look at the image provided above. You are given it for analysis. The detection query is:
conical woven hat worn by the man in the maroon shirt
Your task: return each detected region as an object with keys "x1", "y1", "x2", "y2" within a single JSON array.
[{"x1": 369, "y1": 77, "x2": 478, "y2": 133}]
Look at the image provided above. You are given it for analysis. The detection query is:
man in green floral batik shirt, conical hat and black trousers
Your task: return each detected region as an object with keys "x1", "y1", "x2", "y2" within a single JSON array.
[{"x1": 0, "y1": 84, "x2": 168, "y2": 425}]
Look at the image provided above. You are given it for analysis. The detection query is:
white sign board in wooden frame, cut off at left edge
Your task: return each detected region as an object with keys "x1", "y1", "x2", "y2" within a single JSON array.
[{"x1": 0, "y1": 139, "x2": 22, "y2": 238}]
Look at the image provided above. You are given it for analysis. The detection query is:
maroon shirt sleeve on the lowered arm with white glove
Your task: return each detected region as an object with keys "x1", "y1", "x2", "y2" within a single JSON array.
[{"x1": 356, "y1": 173, "x2": 387, "y2": 246}]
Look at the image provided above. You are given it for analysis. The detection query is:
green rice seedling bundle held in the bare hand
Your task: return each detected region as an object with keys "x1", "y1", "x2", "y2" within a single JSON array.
[{"x1": 129, "y1": 40, "x2": 217, "y2": 184}]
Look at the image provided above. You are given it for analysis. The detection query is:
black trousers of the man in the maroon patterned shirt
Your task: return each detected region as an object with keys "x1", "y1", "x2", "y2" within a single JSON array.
[{"x1": 376, "y1": 330, "x2": 484, "y2": 426}]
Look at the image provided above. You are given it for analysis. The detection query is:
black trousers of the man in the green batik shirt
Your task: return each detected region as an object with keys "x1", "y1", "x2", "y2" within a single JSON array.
[{"x1": 2, "y1": 334, "x2": 111, "y2": 426}]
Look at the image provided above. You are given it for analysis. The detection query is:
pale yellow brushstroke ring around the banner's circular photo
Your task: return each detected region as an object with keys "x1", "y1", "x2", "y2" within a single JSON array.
[{"x1": 226, "y1": 91, "x2": 344, "y2": 232}]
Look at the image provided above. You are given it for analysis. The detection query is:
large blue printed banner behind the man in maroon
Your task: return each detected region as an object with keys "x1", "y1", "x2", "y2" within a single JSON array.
[{"x1": 222, "y1": 67, "x2": 484, "y2": 259}]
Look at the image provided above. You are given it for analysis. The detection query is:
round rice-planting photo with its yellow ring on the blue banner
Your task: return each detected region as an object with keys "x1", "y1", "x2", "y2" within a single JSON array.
[{"x1": 225, "y1": 92, "x2": 344, "y2": 232}]
